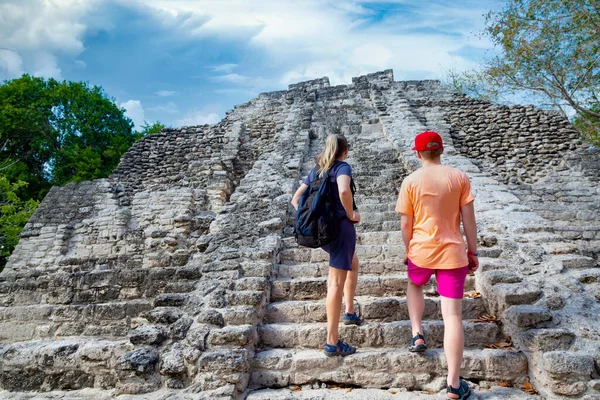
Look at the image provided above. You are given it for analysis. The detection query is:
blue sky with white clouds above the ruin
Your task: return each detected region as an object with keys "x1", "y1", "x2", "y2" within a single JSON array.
[{"x1": 0, "y1": 0, "x2": 501, "y2": 126}]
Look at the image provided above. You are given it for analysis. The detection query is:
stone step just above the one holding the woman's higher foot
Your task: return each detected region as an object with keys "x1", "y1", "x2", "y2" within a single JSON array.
[{"x1": 265, "y1": 296, "x2": 486, "y2": 324}]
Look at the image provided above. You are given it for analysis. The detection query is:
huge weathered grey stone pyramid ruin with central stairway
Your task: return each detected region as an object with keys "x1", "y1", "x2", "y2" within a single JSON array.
[{"x1": 0, "y1": 70, "x2": 600, "y2": 400}]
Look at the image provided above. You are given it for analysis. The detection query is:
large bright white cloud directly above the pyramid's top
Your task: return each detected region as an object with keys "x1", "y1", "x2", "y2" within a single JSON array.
[{"x1": 142, "y1": 0, "x2": 492, "y2": 88}]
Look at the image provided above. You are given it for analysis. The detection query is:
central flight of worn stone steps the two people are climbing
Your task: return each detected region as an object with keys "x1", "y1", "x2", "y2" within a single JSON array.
[{"x1": 249, "y1": 102, "x2": 527, "y2": 399}]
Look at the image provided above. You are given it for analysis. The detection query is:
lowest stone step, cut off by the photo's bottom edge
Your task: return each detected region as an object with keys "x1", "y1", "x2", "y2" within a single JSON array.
[{"x1": 246, "y1": 388, "x2": 540, "y2": 400}]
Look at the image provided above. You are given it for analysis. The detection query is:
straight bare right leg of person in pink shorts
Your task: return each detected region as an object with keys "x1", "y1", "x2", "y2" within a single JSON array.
[{"x1": 440, "y1": 296, "x2": 465, "y2": 398}]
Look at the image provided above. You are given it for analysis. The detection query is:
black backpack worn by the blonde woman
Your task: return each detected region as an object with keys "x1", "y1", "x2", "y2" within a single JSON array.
[{"x1": 294, "y1": 171, "x2": 338, "y2": 249}]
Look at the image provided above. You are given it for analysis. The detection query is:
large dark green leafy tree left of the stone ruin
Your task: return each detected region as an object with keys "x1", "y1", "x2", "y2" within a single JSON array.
[{"x1": 0, "y1": 75, "x2": 137, "y2": 200}]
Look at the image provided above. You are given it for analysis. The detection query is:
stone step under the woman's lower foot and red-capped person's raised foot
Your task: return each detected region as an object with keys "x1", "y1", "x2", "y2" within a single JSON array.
[{"x1": 250, "y1": 349, "x2": 528, "y2": 390}]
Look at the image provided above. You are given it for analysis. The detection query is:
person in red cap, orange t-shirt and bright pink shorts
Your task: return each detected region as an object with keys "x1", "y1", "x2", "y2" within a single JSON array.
[{"x1": 396, "y1": 131, "x2": 479, "y2": 399}]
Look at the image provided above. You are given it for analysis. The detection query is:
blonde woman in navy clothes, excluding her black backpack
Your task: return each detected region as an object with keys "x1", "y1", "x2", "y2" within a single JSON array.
[{"x1": 292, "y1": 135, "x2": 362, "y2": 357}]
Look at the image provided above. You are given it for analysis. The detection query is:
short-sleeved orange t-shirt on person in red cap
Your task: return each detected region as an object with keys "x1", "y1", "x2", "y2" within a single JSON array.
[{"x1": 396, "y1": 165, "x2": 475, "y2": 269}]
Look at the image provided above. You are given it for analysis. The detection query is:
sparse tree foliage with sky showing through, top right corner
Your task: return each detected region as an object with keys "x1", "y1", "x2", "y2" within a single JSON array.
[{"x1": 451, "y1": 0, "x2": 600, "y2": 142}]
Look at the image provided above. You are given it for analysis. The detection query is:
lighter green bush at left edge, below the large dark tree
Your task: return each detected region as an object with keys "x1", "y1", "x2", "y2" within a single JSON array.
[{"x1": 0, "y1": 176, "x2": 39, "y2": 271}]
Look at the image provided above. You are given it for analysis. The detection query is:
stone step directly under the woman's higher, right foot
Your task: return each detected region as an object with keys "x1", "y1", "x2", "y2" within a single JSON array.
[{"x1": 258, "y1": 320, "x2": 501, "y2": 349}]
